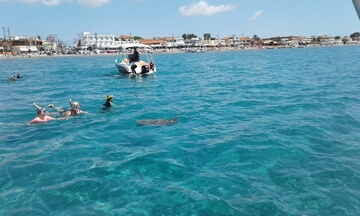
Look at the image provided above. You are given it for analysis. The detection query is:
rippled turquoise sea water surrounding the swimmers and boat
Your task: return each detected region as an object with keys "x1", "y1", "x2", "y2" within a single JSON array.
[{"x1": 0, "y1": 46, "x2": 360, "y2": 215}]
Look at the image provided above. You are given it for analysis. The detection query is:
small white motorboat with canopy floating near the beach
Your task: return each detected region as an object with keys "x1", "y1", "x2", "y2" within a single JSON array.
[{"x1": 114, "y1": 44, "x2": 156, "y2": 75}]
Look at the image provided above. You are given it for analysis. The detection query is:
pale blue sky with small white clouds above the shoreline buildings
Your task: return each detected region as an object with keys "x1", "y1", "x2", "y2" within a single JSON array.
[{"x1": 0, "y1": 0, "x2": 360, "y2": 45}]
